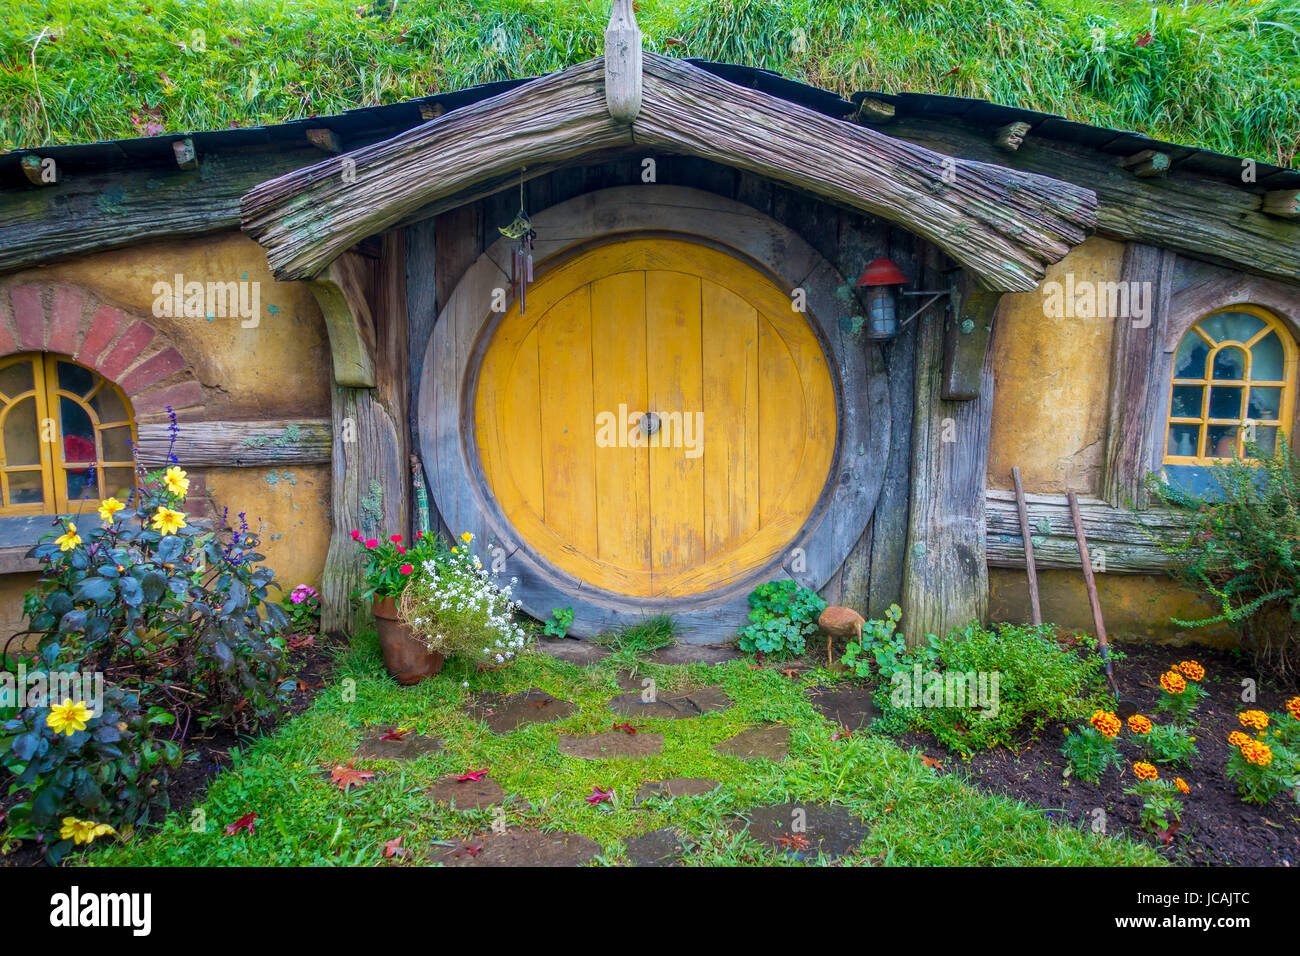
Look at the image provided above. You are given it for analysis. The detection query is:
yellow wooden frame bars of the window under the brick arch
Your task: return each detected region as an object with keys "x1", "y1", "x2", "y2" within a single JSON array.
[{"x1": 0, "y1": 352, "x2": 137, "y2": 515}]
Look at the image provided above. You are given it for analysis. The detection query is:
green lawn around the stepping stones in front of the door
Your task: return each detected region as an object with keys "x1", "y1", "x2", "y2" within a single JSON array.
[{"x1": 91, "y1": 640, "x2": 1160, "y2": 866}]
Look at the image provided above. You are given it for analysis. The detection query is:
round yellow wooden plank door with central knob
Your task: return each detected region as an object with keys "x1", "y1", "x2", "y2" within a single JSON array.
[{"x1": 475, "y1": 238, "x2": 837, "y2": 597}]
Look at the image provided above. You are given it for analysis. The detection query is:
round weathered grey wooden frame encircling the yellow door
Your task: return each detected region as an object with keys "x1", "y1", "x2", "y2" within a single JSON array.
[{"x1": 416, "y1": 183, "x2": 891, "y2": 643}]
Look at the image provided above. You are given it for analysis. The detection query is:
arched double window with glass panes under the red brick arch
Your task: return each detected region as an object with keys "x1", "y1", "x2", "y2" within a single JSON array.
[{"x1": 0, "y1": 352, "x2": 135, "y2": 515}]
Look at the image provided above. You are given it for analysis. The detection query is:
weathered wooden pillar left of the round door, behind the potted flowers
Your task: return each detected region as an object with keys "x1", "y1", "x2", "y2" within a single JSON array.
[{"x1": 311, "y1": 230, "x2": 410, "y2": 633}]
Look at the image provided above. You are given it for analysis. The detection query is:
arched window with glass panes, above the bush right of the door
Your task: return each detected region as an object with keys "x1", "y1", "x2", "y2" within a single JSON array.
[{"x1": 1164, "y1": 306, "x2": 1296, "y2": 485}]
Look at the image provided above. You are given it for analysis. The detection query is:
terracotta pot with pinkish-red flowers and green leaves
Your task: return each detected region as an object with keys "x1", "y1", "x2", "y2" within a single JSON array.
[{"x1": 352, "y1": 531, "x2": 443, "y2": 684}]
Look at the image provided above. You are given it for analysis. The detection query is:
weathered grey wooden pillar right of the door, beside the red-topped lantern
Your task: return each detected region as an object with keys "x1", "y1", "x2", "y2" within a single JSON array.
[{"x1": 902, "y1": 272, "x2": 1001, "y2": 646}]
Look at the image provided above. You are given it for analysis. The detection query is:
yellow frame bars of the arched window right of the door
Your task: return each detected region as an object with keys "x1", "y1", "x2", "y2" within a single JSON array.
[{"x1": 1164, "y1": 304, "x2": 1300, "y2": 466}]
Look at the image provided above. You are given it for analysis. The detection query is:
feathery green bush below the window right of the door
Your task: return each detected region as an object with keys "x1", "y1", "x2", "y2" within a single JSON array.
[{"x1": 1151, "y1": 440, "x2": 1300, "y2": 676}]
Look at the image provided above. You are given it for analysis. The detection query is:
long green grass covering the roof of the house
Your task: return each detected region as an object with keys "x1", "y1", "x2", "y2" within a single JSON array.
[{"x1": 0, "y1": 0, "x2": 1300, "y2": 165}]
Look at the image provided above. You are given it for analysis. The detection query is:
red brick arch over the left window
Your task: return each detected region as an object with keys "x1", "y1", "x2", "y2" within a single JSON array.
[{"x1": 0, "y1": 284, "x2": 203, "y2": 420}]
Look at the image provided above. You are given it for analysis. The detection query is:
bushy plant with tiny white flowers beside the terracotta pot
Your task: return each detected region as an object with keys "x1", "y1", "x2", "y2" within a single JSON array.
[{"x1": 398, "y1": 532, "x2": 532, "y2": 669}]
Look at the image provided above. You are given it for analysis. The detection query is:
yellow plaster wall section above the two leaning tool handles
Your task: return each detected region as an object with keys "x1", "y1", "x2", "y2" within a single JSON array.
[{"x1": 988, "y1": 237, "x2": 1125, "y2": 494}]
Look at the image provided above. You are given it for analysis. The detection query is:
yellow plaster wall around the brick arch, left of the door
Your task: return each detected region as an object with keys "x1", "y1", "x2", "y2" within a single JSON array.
[{"x1": 0, "y1": 232, "x2": 330, "y2": 621}]
